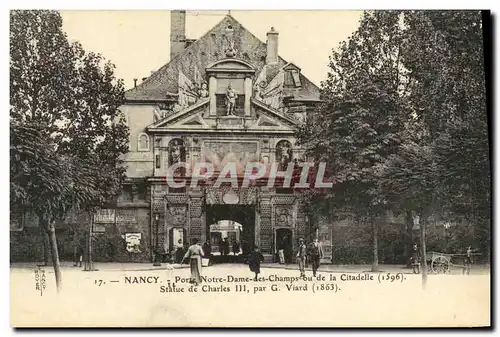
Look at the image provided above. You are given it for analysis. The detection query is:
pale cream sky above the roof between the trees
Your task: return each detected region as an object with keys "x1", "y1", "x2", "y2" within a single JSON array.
[{"x1": 61, "y1": 10, "x2": 362, "y2": 89}]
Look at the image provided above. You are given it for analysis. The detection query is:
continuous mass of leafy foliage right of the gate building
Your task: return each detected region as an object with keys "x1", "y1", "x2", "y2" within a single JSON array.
[{"x1": 298, "y1": 11, "x2": 490, "y2": 262}]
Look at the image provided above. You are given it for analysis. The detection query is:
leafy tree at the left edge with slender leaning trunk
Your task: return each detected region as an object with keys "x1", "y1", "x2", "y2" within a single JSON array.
[{"x1": 10, "y1": 11, "x2": 128, "y2": 290}]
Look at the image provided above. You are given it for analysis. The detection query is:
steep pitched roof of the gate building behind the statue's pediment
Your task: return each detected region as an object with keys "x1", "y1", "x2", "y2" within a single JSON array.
[{"x1": 125, "y1": 15, "x2": 319, "y2": 101}]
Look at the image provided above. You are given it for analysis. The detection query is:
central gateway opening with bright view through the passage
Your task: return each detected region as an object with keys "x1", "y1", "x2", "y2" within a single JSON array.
[{"x1": 205, "y1": 205, "x2": 255, "y2": 263}]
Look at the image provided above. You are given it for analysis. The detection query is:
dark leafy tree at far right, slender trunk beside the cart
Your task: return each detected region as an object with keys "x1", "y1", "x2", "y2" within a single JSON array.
[{"x1": 378, "y1": 11, "x2": 490, "y2": 286}]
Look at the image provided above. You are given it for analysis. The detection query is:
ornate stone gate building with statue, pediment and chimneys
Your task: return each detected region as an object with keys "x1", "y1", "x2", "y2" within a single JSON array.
[{"x1": 116, "y1": 11, "x2": 319, "y2": 259}]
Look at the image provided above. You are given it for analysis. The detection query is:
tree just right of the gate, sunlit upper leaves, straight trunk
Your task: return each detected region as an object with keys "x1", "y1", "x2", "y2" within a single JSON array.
[{"x1": 298, "y1": 11, "x2": 408, "y2": 271}]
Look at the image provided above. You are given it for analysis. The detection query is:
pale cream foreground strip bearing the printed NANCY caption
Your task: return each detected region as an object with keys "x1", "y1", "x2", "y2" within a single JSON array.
[{"x1": 11, "y1": 265, "x2": 490, "y2": 326}]
